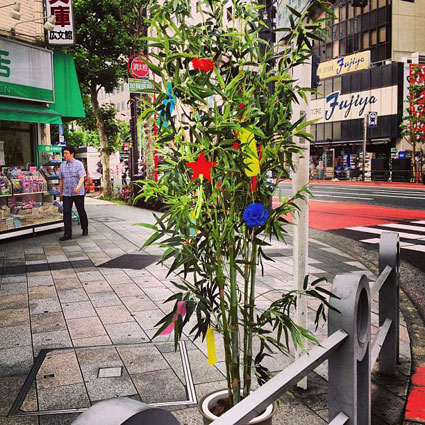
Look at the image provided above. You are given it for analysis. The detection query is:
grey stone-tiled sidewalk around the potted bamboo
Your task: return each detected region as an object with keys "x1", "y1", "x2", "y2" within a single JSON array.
[{"x1": 0, "y1": 199, "x2": 410, "y2": 425}]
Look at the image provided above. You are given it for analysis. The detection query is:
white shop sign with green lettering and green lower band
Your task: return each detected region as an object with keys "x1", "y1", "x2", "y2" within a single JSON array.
[{"x1": 0, "y1": 38, "x2": 55, "y2": 103}]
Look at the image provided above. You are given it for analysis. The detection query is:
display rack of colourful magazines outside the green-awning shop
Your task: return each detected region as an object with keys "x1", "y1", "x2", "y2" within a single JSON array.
[{"x1": 0, "y1": 167, "x2": 63, "y2": 240}]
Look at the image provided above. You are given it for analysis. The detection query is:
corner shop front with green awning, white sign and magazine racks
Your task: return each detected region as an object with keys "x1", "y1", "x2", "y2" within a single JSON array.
[{"x1": 0, "y1": 38, "x2": 84, "y2": 240}]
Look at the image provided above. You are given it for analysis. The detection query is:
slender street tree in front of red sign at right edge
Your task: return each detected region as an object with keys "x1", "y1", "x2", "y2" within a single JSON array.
[{"x1": 400, "y1": 65, "x2": 425, "y2": 180}]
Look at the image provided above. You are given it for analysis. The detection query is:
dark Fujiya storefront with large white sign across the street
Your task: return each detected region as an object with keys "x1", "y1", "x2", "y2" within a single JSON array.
[{"x1": 310, "y1": 63, "x2": 403, "y2": 179}]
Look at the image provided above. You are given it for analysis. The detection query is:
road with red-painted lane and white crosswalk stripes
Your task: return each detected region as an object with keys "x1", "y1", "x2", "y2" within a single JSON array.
[{"x1": 274, "y1": 183, "x2": 425, "y2": 273}]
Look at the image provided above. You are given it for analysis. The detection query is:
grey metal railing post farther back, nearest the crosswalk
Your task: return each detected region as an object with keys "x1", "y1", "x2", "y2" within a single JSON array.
[{"x1": 379, "y1": 232, "x2": 400, "y2": 375}]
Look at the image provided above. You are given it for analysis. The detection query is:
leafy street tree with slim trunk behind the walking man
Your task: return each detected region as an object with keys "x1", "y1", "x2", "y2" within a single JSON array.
[{"x1": 68, "y1": 0, "x2": 147, "y2": 196}]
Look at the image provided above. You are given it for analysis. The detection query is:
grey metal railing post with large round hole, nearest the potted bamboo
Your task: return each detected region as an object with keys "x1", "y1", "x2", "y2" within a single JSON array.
[{"x1": 328, "y1": 274, "x2": 371, "y2": 425}]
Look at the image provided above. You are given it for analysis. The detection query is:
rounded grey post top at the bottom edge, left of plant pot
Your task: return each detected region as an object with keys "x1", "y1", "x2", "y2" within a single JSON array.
[{"x1": 71, "y1": 397, "x2": 180, "y2": 425}]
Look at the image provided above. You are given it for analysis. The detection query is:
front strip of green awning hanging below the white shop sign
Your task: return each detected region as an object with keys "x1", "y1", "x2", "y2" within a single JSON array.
[{"x1": 0, "y1": 99, "x2": 62, "y2": 124}]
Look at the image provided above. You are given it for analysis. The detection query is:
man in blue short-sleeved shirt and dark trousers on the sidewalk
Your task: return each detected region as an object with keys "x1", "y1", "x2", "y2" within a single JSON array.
[{"x1": 59, "y1": 146, "x2": 89, "y2": 241}]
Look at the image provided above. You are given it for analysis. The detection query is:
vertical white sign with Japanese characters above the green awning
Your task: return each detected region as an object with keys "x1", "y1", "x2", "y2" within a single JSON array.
[{"x1": 45, "y1": 0, "x2": 75, "y2": 46}]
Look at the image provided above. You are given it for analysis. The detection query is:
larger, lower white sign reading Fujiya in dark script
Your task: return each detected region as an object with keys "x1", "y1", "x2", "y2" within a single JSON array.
[{"x1": 310, "y1": 86, "x2": 398, "y2": 123}]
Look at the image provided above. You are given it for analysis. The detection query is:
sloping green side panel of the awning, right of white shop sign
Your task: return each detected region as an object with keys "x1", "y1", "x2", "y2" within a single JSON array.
[{"x1": 52, "y1": 51, "x2": 86, "y2": 121}]
